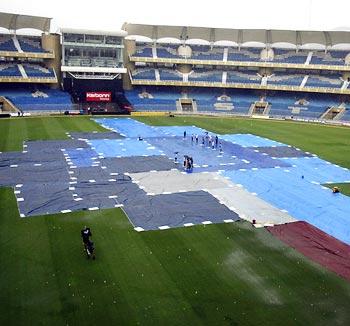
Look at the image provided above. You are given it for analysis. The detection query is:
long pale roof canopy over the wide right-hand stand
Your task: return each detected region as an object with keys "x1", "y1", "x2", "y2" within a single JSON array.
[{"x1": 122, "y1": 23, "x2": 350, "y2": 46}]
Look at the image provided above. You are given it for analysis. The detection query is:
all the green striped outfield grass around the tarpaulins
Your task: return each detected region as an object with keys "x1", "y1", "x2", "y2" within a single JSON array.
[{"x1": 0, "y1": 117, "x2": 350, "y2": 325}]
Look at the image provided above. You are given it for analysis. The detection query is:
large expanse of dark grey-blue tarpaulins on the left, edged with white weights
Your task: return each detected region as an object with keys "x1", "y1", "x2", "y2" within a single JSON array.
[{"x1": 0, "y1": 135, "x2": 239, "y2": 230}]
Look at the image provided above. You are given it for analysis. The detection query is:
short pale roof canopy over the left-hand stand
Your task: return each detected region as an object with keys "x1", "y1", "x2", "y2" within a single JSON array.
[{"x1": 0, "y1": 12, "x2": 52, "y2": 32}]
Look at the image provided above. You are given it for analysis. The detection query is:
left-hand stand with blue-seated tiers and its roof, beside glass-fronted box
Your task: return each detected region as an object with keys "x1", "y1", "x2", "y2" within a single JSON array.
[{"x1": 0, "y1": 13, "x2": 75, "y2": 115}]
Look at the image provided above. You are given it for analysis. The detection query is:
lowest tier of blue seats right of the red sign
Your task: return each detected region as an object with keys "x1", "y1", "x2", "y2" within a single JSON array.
[{"x1": 125, "y1": 86, "x2": 350, "y2": 121}]
